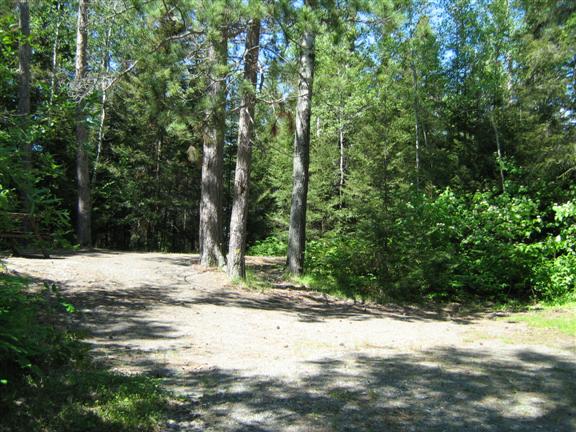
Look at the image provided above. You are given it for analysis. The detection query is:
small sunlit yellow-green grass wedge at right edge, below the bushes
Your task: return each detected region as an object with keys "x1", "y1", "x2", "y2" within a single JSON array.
[{"x1": 507, "y1": 303, "x2": 576, "y2": 337}]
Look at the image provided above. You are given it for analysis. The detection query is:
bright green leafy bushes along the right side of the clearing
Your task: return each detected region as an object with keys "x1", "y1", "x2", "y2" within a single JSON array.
[{"x1": 306, "y1": 187, "x2": 576, "y2": 301}]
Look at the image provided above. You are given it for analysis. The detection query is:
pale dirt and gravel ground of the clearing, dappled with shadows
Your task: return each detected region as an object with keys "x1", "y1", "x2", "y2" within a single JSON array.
[{"x1": 7, "y1": 251, "x2": 576, "y2": 432}]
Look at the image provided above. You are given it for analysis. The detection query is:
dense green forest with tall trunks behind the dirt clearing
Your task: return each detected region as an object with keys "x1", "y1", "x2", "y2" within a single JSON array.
[{"x1": 0, "y1": 0, "x2": 576, "y2": 300}]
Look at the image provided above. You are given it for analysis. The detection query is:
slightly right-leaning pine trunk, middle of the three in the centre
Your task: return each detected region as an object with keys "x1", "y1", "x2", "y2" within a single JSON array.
[{"x1": 228, "y1": 19, "x2": 260, "y2": 279}]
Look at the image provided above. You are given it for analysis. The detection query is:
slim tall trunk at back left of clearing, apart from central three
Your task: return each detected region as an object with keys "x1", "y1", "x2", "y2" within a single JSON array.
[{"x1": 75, "y1": 0, "x2": 92, "y2": 247}]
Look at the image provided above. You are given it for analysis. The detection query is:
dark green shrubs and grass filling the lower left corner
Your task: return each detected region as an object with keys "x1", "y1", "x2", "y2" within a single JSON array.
[{"x1": 0, "y1": 275, "x2": 172, "y2": 432}]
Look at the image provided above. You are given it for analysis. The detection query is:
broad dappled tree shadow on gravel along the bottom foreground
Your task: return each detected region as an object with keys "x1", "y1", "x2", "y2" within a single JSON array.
[{"x1": 160, "y1": 348, "x2": 576, "y2": 432}]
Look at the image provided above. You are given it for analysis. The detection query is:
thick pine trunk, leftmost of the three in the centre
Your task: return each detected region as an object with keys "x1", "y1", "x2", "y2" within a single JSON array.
[{"x1": 200, "y1": 34, "x2": 228, "y2": 267}]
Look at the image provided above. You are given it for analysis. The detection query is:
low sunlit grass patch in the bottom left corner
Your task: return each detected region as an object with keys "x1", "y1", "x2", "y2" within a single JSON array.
[{"x1": 0, "y1": 366, "x2": 170, "y2": 432}]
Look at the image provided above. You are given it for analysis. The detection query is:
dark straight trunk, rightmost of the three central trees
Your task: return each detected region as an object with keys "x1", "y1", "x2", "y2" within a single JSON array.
[{"x1": 287, "y1": 8, "x2": 315, "y2": 275}]
